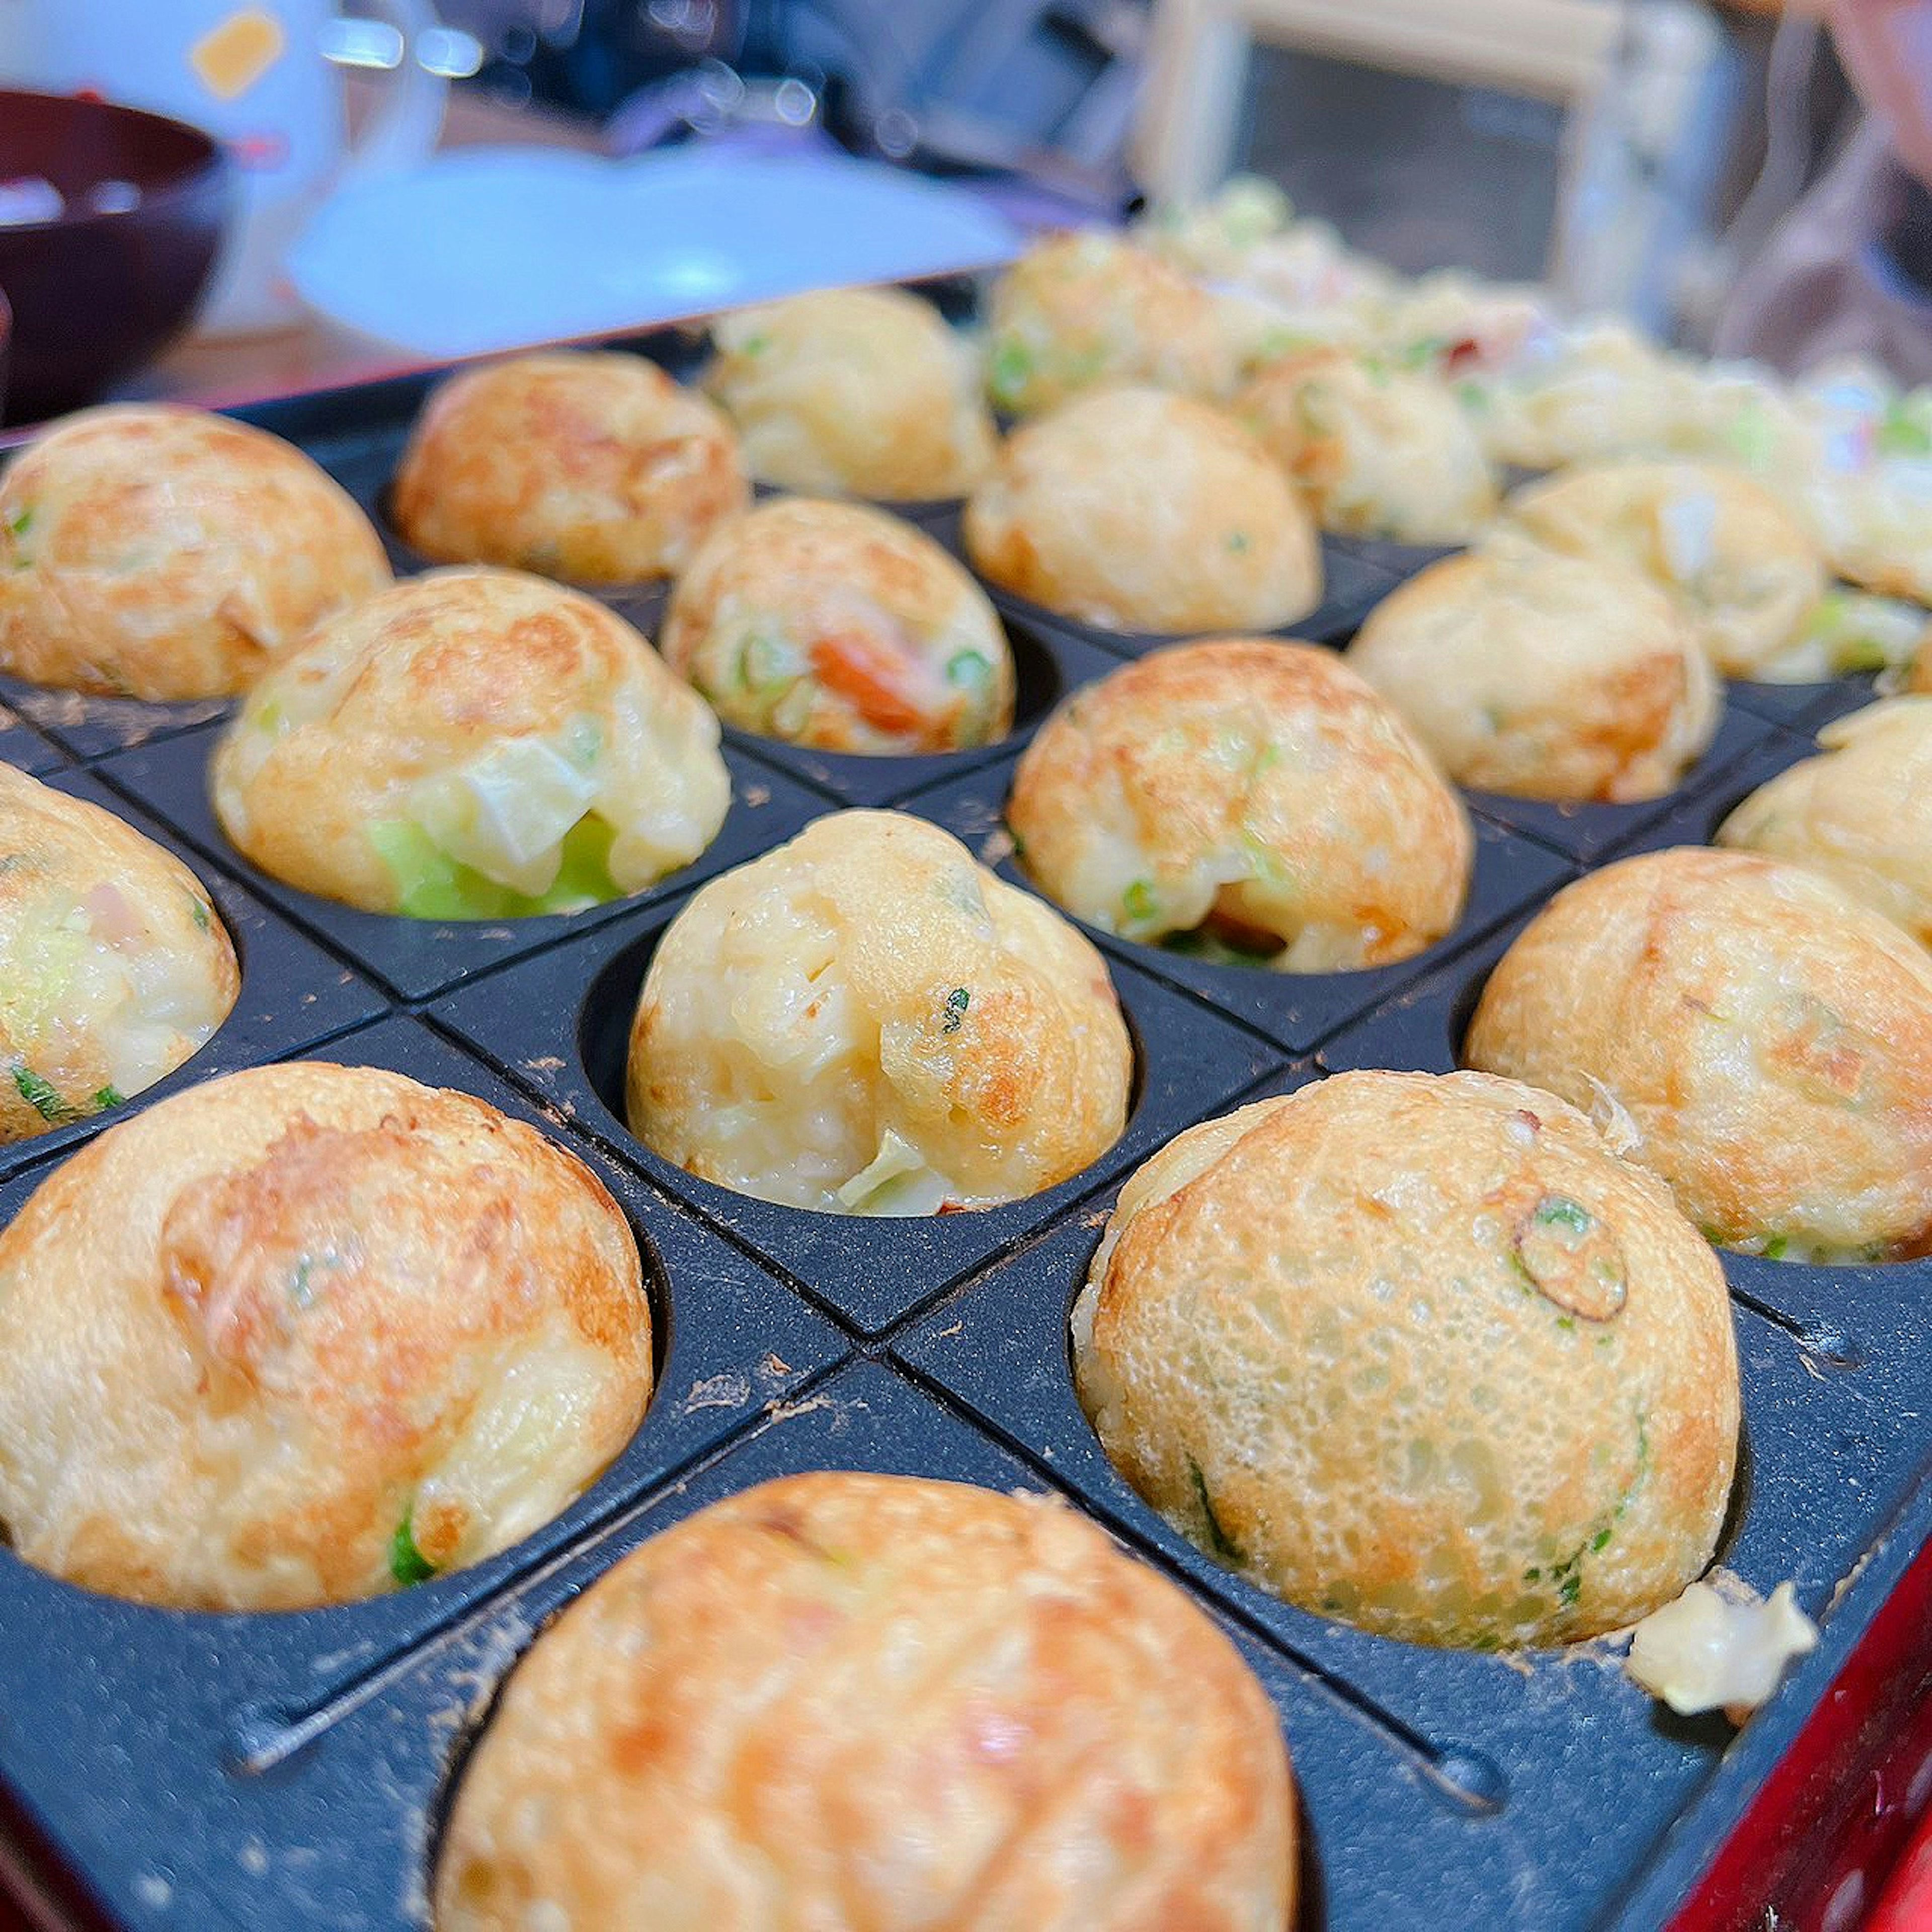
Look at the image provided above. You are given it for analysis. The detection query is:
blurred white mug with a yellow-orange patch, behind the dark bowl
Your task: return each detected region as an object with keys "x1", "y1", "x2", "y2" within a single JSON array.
[{"x1": 0, "y1": 0, "x2": 446, "y2": 334}]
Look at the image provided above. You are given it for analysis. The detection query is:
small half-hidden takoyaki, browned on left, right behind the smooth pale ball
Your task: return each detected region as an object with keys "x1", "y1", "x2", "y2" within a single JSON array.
[{"x1": 1233, "y1": 350, "x2": 1495, "y2": 543}]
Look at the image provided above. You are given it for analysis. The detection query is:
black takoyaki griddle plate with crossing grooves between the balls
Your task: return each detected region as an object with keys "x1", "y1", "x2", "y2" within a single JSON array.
[{"x1": 0, "y1": 286, "x2": 1932, "y2": 1932}]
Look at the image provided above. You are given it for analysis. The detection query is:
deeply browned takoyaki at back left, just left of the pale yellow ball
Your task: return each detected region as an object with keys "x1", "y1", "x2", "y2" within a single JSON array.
[{"x1": 390, "y1": 350, "x2": 750, "y2": 584}]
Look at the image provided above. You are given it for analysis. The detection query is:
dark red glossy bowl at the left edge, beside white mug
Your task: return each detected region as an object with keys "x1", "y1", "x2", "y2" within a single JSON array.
[{"x1": 0, "y1": 89, "x2": 234, "y2": 423}]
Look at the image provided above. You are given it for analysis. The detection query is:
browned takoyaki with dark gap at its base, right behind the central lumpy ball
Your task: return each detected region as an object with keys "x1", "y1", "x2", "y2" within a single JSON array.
[{"x1": 1007, "y1": 637, "x2": 1472, "y2": 972}]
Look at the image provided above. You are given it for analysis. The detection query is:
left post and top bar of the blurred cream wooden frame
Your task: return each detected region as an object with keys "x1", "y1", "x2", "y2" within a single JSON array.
[{"x1": 1134, "y1": 0, "x2": 1623, "y2": 201}]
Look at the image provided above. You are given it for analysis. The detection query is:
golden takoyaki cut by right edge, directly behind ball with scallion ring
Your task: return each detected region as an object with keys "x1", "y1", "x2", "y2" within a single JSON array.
[{"x1": 1463, "y1": 848, "x2": 1932, "y2": 1262}]
